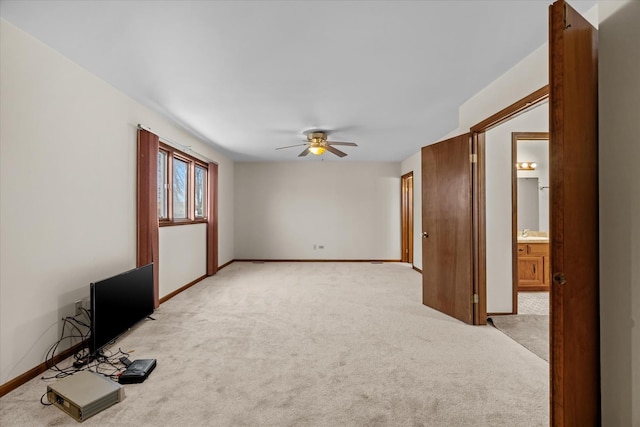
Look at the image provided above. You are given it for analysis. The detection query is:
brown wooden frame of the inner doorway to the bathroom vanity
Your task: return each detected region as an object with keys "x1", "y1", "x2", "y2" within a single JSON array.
[{"x1": 511, "y1": 132, "x2": 549, "y2": 314}]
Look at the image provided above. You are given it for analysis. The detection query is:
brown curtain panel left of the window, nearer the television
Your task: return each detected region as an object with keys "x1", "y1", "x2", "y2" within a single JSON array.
[{"x1": 136, "y1": 129, "x2": 160, "y2": 308}]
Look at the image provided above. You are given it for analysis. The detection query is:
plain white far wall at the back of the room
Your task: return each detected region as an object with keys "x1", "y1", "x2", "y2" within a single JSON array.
[{"x1": 235, "y1": 161, "x2": 400, "y2": 260}]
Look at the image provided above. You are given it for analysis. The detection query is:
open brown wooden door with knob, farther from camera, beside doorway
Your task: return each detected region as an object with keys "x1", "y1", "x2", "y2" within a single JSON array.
[{"x1": 422, "y1": 134, "x2": 473, "y2": 324}]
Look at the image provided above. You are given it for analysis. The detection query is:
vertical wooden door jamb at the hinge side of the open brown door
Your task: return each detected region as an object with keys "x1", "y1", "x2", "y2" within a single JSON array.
[{"x1": 472, "y1": 132, "x2": 487, "y2": 325}]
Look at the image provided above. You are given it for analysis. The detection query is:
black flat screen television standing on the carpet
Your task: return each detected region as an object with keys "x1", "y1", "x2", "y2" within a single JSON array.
[{"x1": 89, "y1": 263, "x2": 154, "y2": 358}]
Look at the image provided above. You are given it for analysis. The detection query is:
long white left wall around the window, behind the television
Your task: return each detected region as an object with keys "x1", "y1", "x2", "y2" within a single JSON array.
[{"x1": 0, "y1": 20, "x2": 233, "y2": 384}]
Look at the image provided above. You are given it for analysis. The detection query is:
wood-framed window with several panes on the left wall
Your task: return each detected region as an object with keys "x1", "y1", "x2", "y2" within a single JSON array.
[{"x1": 158, "y1": 144, "x2": 208, "y2": 225}]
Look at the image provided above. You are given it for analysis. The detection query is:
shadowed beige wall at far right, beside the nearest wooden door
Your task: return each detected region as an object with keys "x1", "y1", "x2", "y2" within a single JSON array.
[{"x1": 598, "y1": 1, "x2": 640, "y2": 426}]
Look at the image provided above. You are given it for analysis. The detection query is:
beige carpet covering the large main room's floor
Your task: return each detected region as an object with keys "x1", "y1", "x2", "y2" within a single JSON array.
[{"x1": 0, "y1": 263, "x2": 549, "y2": 427}]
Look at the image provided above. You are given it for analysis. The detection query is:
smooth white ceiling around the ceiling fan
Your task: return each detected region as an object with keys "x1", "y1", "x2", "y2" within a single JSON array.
[{"x1": 0, "y1": 0, "x2": 595, "y2": 161}]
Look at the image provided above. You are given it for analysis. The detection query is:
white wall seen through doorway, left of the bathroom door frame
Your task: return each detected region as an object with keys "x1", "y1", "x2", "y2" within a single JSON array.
[{"x1": 485, "y1": 103, "x2": 549, "y2": 313}]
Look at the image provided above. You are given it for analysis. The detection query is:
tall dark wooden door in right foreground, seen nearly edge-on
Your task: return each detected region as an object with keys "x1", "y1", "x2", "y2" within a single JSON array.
[{"x1": 549, "y1": 1, "x2": 600, "y2": 426}]
